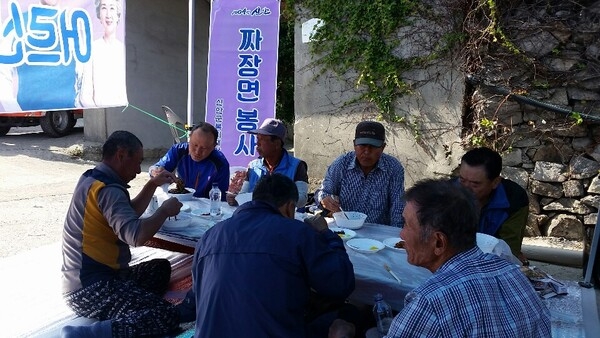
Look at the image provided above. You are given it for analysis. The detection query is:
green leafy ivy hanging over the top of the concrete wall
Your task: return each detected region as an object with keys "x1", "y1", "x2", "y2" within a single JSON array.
[{"x1": 284, "y1": 0, "x2": 421, "y2": 122}]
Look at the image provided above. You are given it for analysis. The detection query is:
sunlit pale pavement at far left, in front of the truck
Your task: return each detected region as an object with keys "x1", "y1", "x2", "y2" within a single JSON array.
[{"x1": 0, "y1": 124, "x2": 153, "y2": 258}]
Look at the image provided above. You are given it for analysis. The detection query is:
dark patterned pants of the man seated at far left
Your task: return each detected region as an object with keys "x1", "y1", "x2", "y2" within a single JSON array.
[{"x1": 65, "y1": 259, "x2": 179, "y2": 337}]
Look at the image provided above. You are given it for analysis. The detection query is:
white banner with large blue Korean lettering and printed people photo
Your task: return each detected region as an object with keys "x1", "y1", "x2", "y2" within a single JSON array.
[{"x1": 0, "y1": 0, "x2": 127, "y2": 113}]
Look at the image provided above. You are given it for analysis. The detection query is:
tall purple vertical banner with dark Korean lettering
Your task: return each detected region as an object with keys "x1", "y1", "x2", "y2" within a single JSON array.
[{"x1": 205, "y1": 0, "x2": 279, "y2": 166}]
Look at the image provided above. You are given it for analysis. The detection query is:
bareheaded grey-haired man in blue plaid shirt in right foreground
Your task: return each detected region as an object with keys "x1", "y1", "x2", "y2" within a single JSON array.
[{"x1": 386, "y1": 180, "x2": 551, "y2": 338}]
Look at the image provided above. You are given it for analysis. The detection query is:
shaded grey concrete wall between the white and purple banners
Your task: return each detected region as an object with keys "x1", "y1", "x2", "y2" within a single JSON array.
[{"x1": 84, "y1": 0, "x2": 210, "y2": 156}]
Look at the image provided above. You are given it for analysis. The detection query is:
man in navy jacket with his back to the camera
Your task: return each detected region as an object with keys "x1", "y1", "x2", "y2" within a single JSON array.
[{"x1": 192, "y1": 174, "x2": 354, "y2": 338}]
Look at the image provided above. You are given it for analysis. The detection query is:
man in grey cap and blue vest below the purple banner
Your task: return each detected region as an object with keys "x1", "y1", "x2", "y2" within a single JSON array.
[{"x1": 227, "y1": 118, "x2": 308, "y2": 208}]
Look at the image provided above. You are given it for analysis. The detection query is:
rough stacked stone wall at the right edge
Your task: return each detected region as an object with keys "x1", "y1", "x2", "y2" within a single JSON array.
[{"x1": 471, "y1": 1, "x2": 600, "y2": 240}]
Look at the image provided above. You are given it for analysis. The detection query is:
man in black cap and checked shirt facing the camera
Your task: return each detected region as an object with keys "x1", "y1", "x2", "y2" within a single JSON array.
[{"x1": 317, "y1": 121, "x2": 404, "y2": 227}]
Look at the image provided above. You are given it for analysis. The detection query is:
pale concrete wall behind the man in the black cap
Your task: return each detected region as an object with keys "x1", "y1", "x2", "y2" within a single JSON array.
[{"x1": 294, "y1": 13, "x2": 464, "y2": 190}]
